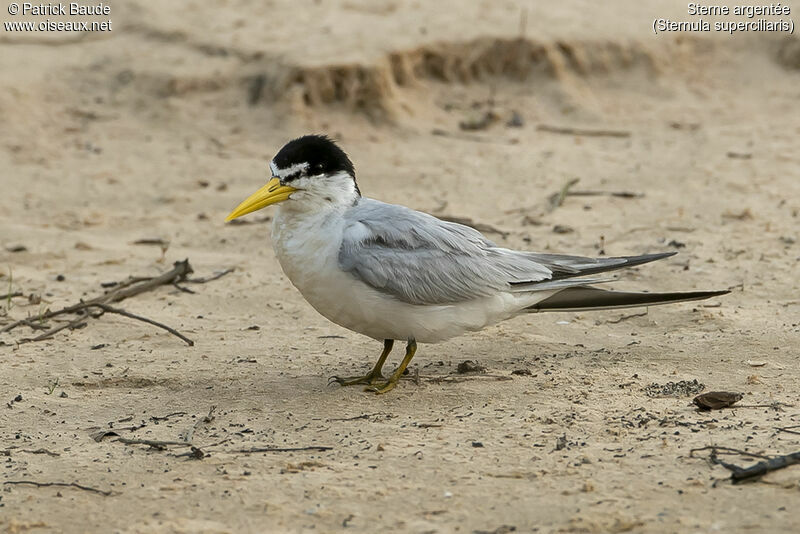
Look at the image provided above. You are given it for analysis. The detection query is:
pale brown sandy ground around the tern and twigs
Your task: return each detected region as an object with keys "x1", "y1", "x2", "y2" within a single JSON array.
[{"x1": 0, "y1": 0, "x2": 800, "y2": 533}]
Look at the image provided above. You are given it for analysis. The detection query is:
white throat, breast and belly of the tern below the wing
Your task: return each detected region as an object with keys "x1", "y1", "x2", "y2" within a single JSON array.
[{"x1": 272, "y1": 205, "x2": 543, "y2": 343}]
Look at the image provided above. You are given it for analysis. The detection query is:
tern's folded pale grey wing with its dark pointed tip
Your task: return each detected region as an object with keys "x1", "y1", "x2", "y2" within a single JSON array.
[{"x1": 339, "y1": 198, "x2": 674, "y2": 304}]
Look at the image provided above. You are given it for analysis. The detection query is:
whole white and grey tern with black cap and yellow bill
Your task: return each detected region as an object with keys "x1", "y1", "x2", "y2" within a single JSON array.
[{"x1": 226, "y1": 135, "x2": 728, "y2": 393}]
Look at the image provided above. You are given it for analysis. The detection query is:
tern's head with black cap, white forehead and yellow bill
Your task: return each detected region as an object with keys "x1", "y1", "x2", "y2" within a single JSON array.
[{"x1": 225, "y1": 135, "x2": 361, "y2": 221}]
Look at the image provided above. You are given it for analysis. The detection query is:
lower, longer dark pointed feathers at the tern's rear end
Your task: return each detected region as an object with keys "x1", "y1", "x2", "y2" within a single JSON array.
[{"x1": 526, "y1": 286, "x2": 730, "y2": 312}]
